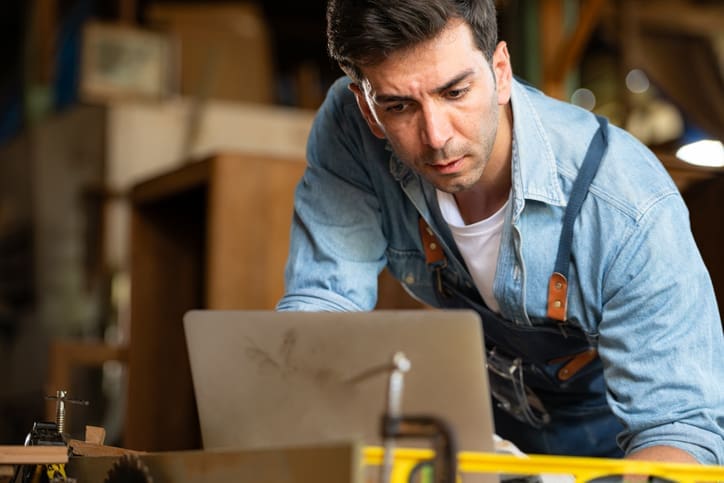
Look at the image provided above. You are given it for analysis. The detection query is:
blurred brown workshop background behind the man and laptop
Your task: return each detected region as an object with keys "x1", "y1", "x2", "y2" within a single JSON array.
[{"x1": 0, "y1": 0, "x2": 724, "y2": 450}]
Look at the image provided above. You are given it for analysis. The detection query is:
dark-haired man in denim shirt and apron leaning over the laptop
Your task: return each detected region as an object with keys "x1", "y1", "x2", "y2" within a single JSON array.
[{"x1": 278, "y1": 0, "x2": 724, "y2": 464}]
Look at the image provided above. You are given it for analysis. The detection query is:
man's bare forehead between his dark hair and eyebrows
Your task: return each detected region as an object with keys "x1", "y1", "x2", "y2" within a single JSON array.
[{"x1": 362, "y1": 20, "x2": 486, "y2": 95}]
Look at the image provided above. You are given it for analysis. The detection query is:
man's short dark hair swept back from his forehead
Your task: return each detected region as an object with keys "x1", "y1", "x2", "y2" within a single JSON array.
[{"x1": 327, "y1": 0, "x2": 498, "y2": 81}]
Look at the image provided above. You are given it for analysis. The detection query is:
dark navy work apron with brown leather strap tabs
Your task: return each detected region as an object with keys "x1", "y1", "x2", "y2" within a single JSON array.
[{"x1": 420, "y1": 118, "x2": 623, "y2": 457}]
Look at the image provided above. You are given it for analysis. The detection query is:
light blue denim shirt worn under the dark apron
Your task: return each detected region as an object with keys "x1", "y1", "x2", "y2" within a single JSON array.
[{"x1": 277, "y1": 78, "x2": 724, "y2": 464}]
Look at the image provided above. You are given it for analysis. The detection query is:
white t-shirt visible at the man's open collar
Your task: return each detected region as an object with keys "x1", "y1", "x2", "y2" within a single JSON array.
[{"x1": 437, "y1": 190, "x2": 510, "y2": 312}]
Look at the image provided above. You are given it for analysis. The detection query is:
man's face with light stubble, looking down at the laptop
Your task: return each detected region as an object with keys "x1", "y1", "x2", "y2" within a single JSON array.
[{"x1": 352, "y1": 21, "x2": 510, "y2": 193}]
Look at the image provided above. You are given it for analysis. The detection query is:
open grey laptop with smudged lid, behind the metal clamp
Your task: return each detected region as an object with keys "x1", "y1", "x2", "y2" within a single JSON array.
[{"x1": 184, "y1": 310, "x2": 493, "y2": 458}]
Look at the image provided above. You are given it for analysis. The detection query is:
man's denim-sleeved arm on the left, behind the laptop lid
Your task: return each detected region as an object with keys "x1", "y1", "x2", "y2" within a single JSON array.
[{"x1": 277, "y1": 80, "x2": 389, "y2": 311}]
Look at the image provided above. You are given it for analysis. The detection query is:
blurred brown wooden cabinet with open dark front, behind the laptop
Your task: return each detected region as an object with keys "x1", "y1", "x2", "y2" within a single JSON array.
[{"x1": 123, "y1": 154, "x2": 305, "y2": 451}]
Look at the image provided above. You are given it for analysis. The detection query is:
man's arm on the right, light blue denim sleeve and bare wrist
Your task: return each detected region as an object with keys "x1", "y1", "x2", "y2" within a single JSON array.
[{"x1": 599, "y1": 195, "x2": 724, "y2": 464}]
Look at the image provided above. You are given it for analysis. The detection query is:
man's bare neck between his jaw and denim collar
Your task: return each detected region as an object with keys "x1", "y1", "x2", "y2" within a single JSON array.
[{"x1": 455, "y1": 104, "x2": 513, "y2": 225}]
